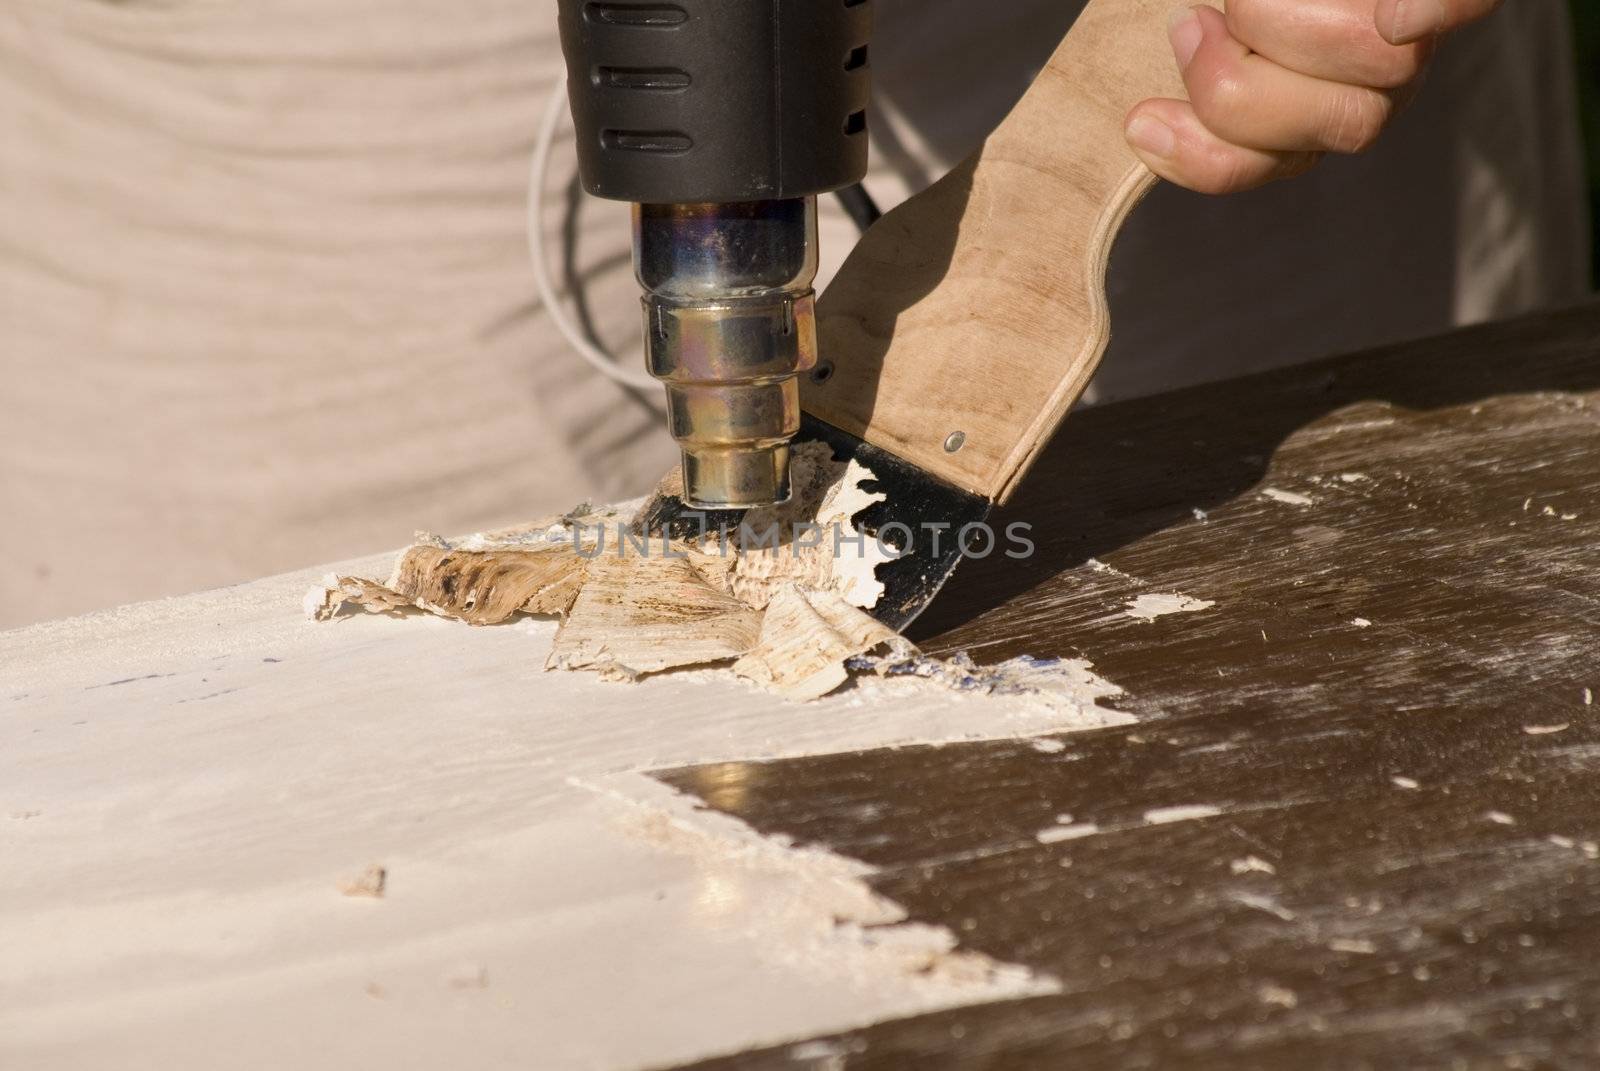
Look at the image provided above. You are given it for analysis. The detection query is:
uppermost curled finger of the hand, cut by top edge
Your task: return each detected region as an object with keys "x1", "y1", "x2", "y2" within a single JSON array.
[{"x1": 1227, "y1": 0, "x2": 1434, "y2": 90}]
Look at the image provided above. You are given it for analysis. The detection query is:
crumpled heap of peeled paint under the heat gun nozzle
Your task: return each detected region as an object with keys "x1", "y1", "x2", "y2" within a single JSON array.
[{"x1": 306, "y1": 443, "x2": 1117, "y2": 706}]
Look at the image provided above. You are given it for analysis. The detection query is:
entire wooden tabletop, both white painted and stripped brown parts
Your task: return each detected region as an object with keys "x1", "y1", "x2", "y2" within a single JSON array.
[{"x1": 12, "y1": 296, "x2": 1600, "y2": 1068}]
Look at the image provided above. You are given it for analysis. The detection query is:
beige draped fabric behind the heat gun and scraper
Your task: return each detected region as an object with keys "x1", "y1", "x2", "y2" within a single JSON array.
[{"x1": 0, "y1": 0, "x2": 1586, "y2": 626}]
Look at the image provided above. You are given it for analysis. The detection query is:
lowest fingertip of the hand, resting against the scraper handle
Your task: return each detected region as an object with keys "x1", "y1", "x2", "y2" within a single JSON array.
[{"x1": 1126, "y1": 99, "x2": 1317, "y2": 194}]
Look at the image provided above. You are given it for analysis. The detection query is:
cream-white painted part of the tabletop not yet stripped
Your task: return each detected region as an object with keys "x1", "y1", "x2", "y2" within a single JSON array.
[{"x1": 0, "y1": 560, "x2": 1126, "y2": 1071}]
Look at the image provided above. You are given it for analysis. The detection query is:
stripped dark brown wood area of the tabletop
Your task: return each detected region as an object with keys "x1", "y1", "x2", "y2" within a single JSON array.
[{"x1": 661, "y1": 304, "x2": 1600, "y2": 1071}]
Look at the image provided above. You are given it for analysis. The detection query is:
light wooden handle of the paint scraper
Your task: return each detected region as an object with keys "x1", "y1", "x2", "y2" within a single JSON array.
[{"x1": 802, "y1": 0, "x2": 1203, "y2": 499}]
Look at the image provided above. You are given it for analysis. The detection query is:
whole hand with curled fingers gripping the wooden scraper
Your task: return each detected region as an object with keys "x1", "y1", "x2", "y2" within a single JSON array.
[{"x1": 1125, "y1": 0, "x2": 1504, "y2": 194}]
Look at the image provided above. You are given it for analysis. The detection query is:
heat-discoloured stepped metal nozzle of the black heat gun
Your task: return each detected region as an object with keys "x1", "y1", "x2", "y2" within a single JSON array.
[{"x1": 634, "y1": 197, "x2": 816, "y2": 509}]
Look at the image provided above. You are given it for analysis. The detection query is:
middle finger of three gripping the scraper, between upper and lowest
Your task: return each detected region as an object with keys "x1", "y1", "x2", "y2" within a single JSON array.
[{"x1": 1171, "y1": 6, "x2": 1395, "y2": 152}]
